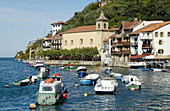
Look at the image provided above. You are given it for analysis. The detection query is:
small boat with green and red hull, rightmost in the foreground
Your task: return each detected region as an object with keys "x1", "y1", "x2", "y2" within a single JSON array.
[{"x1": 128, "y1": 81, "x2": 141, "y2": 90}]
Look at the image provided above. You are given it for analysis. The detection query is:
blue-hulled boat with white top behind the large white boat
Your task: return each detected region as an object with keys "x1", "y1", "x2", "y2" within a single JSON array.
[{"x1": 80, "y1": 74, "x2": 99, "y2": 85}]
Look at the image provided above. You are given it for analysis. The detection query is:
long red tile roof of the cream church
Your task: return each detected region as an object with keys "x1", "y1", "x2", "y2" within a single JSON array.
[{"x1": 63, "y1": 25, "x2": 115, "y2": 33}]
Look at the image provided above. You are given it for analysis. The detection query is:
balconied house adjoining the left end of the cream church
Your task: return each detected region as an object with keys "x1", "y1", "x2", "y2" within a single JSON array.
[{"x1": 43, "y1": 33, "x2": 62, "y2": 50}]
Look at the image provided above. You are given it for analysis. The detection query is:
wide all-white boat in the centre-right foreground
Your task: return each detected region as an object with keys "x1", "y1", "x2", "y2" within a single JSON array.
[{"x1": 94, "y1": 77, "x2": 118, "y2": 94}]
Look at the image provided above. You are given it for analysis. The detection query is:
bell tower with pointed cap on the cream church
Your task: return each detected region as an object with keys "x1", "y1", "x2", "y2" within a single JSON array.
[{"x1": 96, "y1": 11, "x2": 109, "y2": 30}]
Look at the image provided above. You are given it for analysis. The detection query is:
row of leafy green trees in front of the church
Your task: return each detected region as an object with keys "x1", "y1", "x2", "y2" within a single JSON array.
[{"x1": 38, "y1": 47, "x2": 98, "y2": 60}]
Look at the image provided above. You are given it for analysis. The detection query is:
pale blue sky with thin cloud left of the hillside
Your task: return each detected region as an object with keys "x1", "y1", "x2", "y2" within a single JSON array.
[{"x1": 0, "y1": 0, "x2": 97, "y2": 57}]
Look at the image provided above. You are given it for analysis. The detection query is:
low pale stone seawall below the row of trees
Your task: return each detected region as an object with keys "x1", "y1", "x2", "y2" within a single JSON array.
[{"x1": 23, "y1": 60, "x2": 102, "y2": 66}]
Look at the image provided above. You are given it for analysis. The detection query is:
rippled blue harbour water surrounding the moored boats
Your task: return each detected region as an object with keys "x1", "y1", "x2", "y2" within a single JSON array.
[{"x1": 0, "y1": 58, "x2": 170, "y2": 111}]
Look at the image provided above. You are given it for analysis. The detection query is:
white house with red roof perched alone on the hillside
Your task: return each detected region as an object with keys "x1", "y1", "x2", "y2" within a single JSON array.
[{"x1": 51, "y1": 21, "x2": 65, "y2": 36}]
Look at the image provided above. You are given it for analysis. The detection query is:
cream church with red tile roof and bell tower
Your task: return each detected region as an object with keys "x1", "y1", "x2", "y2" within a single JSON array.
[{"x1": 62, "y1": 11, "x2": 115, "y2": 52}]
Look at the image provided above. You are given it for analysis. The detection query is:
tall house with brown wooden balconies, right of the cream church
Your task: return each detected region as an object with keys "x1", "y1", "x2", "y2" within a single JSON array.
[{"x1": 111, "y1": 19, "x2": 141, "y2": 67}]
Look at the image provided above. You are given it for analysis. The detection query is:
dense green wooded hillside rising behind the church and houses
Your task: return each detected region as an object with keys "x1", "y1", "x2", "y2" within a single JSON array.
[{"x1": 59, "y1": 0, "x2": 170, "y2": 33}]
